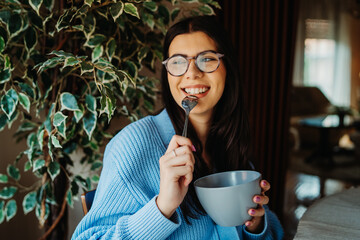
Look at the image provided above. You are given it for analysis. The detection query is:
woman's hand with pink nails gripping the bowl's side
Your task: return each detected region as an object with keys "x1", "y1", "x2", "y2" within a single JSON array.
[{"x1": 245, "y1": 180, "x2": 270, "y2": 233}]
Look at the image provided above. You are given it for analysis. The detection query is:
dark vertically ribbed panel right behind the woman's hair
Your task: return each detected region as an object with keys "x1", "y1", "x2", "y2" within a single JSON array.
[{"x1": 217, "y1": 0, "x2": 299, "y2": 219}]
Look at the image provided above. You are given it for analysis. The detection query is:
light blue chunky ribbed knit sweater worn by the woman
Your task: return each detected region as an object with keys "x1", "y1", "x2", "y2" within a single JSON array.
[{"x1": 72, "y1": 110, "x2": 283, "y2": 240}]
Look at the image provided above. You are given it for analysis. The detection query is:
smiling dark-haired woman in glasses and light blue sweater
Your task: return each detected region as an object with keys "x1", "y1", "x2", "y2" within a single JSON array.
[{"x1": 73, "y1": 17, "x2": 283, "y2": 240}]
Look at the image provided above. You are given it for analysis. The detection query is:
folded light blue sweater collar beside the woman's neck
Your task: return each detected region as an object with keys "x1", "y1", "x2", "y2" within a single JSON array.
[{"x1": 153, "y1": 109, "x2": 175, "y2": 148}]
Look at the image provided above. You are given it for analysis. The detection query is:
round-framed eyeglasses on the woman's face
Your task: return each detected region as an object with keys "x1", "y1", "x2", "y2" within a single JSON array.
[{"x1": 162, "y1": 50, "x2": 224, "y2": 77}]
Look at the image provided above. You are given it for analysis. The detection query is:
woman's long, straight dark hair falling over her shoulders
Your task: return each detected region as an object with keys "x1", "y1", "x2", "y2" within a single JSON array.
[{"x1": 161, "y1": 16, "x2": 249, "y2": 224}]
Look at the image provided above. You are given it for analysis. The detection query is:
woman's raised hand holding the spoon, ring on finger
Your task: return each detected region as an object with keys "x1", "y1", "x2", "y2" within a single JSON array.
[{"x1": 156, "y1": 135, "x2": 195, "y2": 218}]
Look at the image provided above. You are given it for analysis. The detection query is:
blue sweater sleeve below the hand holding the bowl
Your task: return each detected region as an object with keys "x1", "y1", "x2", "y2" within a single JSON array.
[{"x1": 237, "y1": 205, "x2": 284, "y2": 240}]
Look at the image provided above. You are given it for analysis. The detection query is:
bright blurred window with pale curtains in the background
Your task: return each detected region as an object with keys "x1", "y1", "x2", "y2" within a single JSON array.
[{"x1": 293, "y1": 0, "x2": 351, "y2": 107}]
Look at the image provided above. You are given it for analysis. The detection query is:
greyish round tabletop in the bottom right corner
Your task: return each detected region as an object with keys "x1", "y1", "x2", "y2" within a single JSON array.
[{"x1": 294, "y1": 188, "x2": 360, "y2": 240}]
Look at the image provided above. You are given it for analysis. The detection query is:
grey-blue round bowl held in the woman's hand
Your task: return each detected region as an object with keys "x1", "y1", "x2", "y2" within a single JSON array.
[{"x1": 194, "y1": 171, "x2": 261, "y2": 227}]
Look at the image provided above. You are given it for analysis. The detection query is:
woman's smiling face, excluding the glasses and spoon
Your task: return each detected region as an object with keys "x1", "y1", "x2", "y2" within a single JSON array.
[{"x1": 167, "y1": 32, "x2": 226, "y2": 119}]
